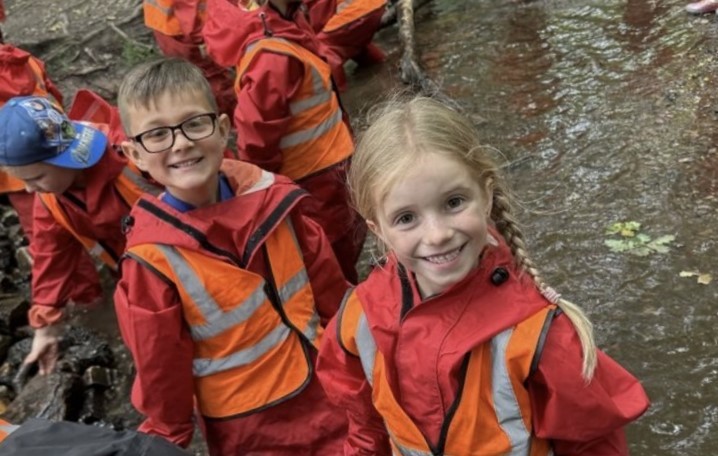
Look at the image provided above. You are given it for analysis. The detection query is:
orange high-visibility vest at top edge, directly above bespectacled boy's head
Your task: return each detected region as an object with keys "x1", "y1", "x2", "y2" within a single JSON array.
[{"x1": 142, "y1": 0, "x2": 207, "y2": 36}]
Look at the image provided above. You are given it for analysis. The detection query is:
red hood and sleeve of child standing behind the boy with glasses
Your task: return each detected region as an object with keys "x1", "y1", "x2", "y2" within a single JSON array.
[{"x1": 202, "y1": 0, "x2": 342, "y2": 140}]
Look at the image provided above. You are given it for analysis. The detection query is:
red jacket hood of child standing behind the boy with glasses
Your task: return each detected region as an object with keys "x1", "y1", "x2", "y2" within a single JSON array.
[{"x1": 202, "y1": 0, "x2": 326, "y2": 67}]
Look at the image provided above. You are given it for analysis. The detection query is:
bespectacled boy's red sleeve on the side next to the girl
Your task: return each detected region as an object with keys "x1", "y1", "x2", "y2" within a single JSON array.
[{"x1": 292, "y1": 211, "x2": 349, "y2": 327}]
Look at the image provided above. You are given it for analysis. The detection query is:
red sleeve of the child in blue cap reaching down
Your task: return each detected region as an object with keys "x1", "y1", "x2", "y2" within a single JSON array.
[{"x1": 29, "y1": 197, "x2": 102, "y2": 328}]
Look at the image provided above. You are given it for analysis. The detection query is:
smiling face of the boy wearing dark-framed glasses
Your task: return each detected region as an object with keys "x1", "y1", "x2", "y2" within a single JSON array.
[{"x1": 122, "y1": 90, "x2": 230, "y2": 207}]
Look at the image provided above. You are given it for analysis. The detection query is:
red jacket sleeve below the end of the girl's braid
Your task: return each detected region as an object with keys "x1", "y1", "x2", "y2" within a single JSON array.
[{"x1": 528, "y1": 315, "x2": 649, "y2": 456}]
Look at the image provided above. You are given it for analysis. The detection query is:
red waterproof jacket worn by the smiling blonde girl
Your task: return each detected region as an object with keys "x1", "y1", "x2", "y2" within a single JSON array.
[{"x1": 318, "y1": 233, "x2": 648, "y2": 456}]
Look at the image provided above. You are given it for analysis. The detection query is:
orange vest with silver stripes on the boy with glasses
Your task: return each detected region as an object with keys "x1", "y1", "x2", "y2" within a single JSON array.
[{"x1": 126, "y1": 167, "x2": 323, "y2": 418}]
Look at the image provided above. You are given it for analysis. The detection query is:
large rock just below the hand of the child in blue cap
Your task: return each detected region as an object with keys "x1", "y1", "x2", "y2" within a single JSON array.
[{"x1": 2, "y1": 372, "x2": 84, "y2": 423}]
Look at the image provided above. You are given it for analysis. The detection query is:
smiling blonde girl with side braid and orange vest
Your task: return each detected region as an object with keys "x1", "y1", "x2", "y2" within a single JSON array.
[{"x1": 318, "y1": 98, "x2": 648, "y2": 455}]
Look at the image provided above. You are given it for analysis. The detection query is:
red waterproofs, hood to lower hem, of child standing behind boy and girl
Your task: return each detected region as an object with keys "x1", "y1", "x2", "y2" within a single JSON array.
[{"x1": 203, "y1": 0, "x2": 366, "y2": 281}]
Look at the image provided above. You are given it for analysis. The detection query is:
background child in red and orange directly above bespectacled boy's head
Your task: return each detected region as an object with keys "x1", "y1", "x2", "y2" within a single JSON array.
[{"x1": 142, "y1": 0, "x2": 237, "y2": 114}]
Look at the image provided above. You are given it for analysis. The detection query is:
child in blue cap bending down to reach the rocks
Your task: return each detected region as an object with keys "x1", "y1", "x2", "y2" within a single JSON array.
[{"x1": 0, "y1": 96, "x2": 158, "y2": 374}]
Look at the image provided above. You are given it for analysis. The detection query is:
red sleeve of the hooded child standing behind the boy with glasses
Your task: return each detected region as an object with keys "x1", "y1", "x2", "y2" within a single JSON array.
[{"x1": 234, "y1": 52, "x2": 304, "y2": 172}]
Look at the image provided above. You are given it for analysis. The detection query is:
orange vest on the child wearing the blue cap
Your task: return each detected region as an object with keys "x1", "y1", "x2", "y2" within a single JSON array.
[{"x1": 37, "y1": 162, "x2": 161, "y2": 271}]
